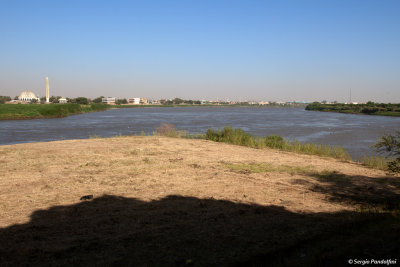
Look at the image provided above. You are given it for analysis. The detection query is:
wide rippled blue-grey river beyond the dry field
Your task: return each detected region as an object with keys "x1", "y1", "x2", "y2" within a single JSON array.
[{"x1": 0, "y1": 107, "x2": 400, "y2": 158}]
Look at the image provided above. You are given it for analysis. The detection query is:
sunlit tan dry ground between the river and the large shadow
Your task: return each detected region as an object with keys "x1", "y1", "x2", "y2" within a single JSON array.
[{"x1": 0, "y1": 137, "x2": 394, "y2": 227}]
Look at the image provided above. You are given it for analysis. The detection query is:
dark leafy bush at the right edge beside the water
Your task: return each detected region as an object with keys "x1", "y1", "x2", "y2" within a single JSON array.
[{"x1": 374, "y1": 131, "x2": 400, "y2": 172}]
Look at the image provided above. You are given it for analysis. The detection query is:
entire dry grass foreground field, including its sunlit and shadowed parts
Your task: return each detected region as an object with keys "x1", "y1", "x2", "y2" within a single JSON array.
[{"x1": 0, "y1": 136, "x2": 400, "y2": 266}]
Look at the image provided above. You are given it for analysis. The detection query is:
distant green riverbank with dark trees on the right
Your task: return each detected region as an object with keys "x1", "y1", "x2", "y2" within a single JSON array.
[{"x1": 306, "y1": 102, "x2": 400, "y2": 117}]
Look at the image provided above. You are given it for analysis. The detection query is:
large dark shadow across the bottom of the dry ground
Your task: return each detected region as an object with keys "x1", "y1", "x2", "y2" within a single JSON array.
[{"x1": 0, "y1": 195, "x2": 400, "y2": 266}]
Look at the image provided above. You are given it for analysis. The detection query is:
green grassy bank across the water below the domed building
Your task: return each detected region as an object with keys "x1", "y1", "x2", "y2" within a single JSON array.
[{"x1": 0, "y1": 104, "x2": 110, "y2": 120}]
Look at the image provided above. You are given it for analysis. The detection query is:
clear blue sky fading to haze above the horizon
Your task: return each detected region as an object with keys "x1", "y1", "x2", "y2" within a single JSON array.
[{"x1": 0, "y1": 0, "x2": 400, "y2": 103}]
